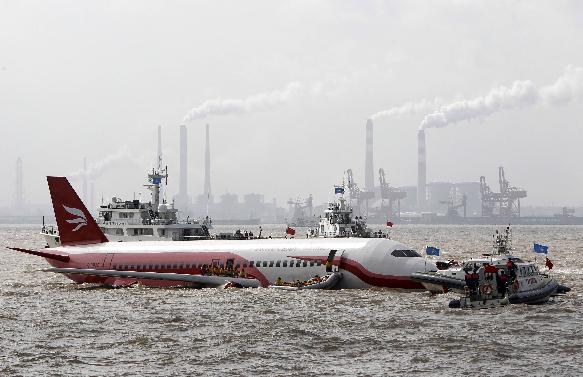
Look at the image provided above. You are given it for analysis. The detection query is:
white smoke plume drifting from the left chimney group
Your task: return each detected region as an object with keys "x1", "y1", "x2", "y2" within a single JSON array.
[{"x1": 183, "y1": 82, "x2": 305, "y2": 123}]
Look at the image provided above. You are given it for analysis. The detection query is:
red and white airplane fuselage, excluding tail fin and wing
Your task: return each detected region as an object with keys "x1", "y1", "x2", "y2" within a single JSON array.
[{"x1": 46, "y1": 238, "x2": 435, "y2": 289}]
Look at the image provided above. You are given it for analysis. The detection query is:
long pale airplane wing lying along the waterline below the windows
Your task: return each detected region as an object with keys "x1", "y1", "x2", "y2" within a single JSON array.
[{"x1": 43, "y1": 268, "x2": 261, "y2": 288}]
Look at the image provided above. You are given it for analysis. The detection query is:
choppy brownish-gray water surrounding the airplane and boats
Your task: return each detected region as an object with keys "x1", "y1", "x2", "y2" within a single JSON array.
[{"x1": 0, "y1": 225, "x2": 583, "y2": 376}]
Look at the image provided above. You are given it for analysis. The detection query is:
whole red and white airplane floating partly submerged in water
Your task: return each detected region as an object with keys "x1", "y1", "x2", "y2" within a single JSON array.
[{"x1": 10, "y1": 177, "x2": 437, "y2": 290}]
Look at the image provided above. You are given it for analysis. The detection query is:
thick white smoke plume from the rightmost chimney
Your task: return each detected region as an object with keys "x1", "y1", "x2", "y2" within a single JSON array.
[{"x1": 420, "y1": 66, "x2": 583, "y2": 129}]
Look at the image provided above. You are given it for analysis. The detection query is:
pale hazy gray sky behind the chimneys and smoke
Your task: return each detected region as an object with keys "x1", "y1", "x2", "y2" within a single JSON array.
[{"x1": 0, "y1": 0, "x2": 583, "y2": 207}]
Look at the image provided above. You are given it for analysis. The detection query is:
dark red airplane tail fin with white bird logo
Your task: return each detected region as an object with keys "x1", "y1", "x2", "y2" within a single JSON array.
[{"x1": 47, "y1": 177, "x2": 107, "y2": 246}]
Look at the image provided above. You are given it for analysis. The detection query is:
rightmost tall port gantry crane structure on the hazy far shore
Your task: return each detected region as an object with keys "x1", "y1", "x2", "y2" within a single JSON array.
[{"x1": 480, "y1": 166, "x2": 526, "y2": 217}]
